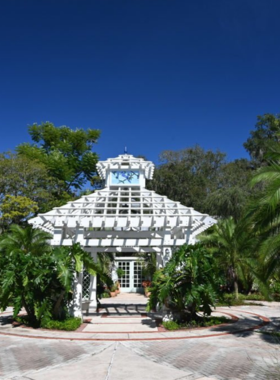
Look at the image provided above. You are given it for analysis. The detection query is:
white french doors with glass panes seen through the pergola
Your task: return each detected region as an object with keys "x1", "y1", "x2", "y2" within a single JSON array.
[{"x1": 116, "y1": 258, "x2": 143, "y2": 293}]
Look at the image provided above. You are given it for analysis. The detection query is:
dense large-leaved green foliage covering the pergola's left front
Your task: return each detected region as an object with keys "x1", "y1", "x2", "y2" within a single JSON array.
[{"x1": 0, "y1": 225, "x2": 107, "y2": 326}]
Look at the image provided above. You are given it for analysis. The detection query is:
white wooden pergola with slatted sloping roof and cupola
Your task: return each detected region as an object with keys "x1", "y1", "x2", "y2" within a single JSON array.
[{"x1": 29, "y1": 154, "x2": 216, "y2": 316}]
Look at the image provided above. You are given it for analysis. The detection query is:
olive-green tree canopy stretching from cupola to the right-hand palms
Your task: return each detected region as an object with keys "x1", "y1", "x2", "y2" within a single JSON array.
[{"x1": 148, "y1": 145, "x2": 252, "y2": 220}]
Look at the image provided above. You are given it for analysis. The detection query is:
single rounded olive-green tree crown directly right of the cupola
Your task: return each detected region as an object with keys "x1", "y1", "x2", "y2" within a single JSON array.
[{"x1": 148, "y1": 145, "x2": 225, "y2": 212}]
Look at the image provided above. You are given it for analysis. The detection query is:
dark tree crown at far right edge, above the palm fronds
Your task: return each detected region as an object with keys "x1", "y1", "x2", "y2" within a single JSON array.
[{"x1": 243, "y1": 113, "x2": 280, "y2": 166}]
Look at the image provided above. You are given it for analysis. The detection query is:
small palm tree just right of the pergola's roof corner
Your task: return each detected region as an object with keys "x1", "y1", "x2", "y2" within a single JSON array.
[{"x1": 200, "y1": 217, "x2": 256, "y2": 299}]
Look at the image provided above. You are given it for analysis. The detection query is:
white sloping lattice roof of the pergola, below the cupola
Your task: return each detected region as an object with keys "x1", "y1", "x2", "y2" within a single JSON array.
[{"x1": 30, "y1": 187, "x2": 215, "y2": 232}]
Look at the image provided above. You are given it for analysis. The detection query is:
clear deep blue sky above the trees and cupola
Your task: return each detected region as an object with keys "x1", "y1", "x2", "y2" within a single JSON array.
[{"x1": 0, "y1": 0, "x2": 280, "y2": 165}]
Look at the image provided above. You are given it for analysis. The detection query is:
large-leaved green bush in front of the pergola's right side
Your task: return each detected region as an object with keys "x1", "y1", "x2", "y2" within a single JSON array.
[{"x1": 148, "y1": 244, "x2": 219, "y2": 321}]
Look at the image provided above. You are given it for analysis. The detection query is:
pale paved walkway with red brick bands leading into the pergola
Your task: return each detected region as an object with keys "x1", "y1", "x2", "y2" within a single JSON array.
[{"x1": 0, "y1": 295, "x2": 280, "y2": 380}]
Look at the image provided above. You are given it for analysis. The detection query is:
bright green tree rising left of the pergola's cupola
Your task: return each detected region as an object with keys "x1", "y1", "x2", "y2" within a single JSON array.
[{"x1": 16, "y1": 122, "x2": 100, "y2": 192}]
